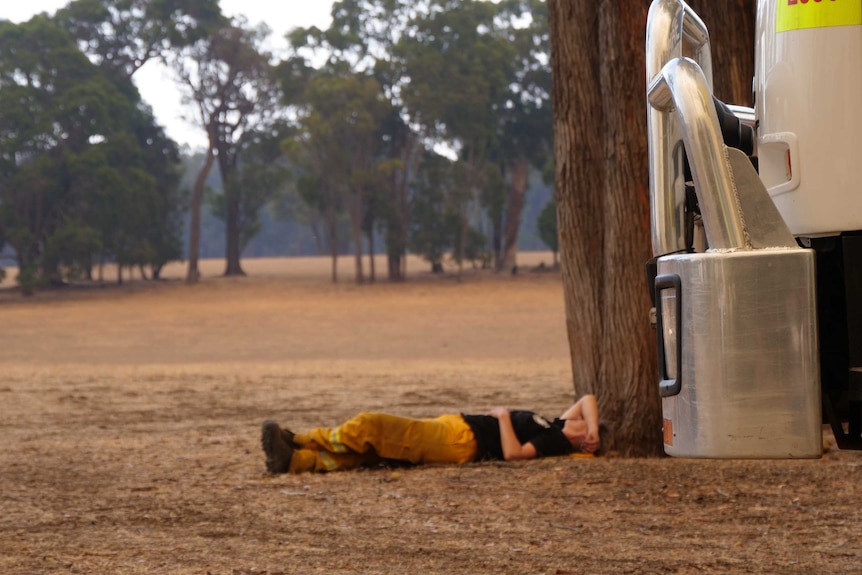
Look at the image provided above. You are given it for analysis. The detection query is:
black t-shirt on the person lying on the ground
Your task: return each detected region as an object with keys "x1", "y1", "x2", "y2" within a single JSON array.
[{"x1": 461, "y1": 411, "x2": 573, "y2": 461}]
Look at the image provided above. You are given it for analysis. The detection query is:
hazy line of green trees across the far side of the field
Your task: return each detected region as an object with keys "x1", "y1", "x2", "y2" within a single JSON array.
[{"x1": 0, "y1": 0, "x2": 556, "y2": 293}]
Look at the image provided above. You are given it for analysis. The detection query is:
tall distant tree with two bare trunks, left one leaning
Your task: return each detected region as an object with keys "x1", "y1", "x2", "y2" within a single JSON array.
[{"x1": 169, "y1": 19, "x2": 278, "y2": 282}]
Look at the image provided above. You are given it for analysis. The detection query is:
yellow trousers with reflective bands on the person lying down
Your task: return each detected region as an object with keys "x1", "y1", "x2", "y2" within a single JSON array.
[{"x1": 289, "y1": 413, "x2": 477, "y2": 473}]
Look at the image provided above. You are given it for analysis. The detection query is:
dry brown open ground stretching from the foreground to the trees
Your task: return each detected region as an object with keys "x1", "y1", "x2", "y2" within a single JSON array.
[{"x1": 0, "y1": 260, "x2": 862, "y2": 575}]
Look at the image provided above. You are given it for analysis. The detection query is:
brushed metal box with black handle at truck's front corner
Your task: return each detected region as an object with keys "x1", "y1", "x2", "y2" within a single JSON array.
[{"x1": 656, "y1": 249, "x2": 822, "y2": 458}]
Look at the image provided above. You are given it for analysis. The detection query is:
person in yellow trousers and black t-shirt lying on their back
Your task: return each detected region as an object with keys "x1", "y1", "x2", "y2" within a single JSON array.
[{"x1": 261, "y1": 395, "x2": 609, "y2": 473}]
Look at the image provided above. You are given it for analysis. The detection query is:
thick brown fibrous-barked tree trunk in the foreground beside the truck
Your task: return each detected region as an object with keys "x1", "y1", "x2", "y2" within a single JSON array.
[{"x1": 548, "y1": 0, "x2": 662, "y2": 455}]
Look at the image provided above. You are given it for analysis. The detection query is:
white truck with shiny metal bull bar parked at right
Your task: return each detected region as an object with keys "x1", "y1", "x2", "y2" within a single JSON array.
[{"x1": 646, "y1": 0, "x2": 862, "y2": 458}]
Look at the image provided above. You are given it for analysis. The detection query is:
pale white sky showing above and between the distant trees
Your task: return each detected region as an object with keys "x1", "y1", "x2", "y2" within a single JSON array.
[{"x1": 7, "y1": 0, "x2": 332, "y2": 147}]
